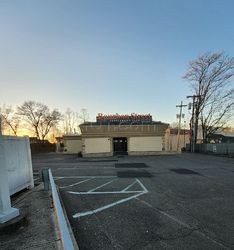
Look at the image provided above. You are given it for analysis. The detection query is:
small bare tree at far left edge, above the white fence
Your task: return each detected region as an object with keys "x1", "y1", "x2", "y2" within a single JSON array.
[{"x1": 0, "y1": 105, "x2": 20, "y2": 136}]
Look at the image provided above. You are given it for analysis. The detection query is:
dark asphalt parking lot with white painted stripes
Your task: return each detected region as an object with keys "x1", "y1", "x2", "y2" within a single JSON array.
[{"x1": 33, "y1": 153, "x2": 234, "y2": 250}]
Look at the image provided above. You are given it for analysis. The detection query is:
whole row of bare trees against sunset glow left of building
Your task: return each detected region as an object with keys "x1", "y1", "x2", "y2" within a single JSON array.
[{"x1": 0, "y1": 100, "x2": 89, "y2": 140}]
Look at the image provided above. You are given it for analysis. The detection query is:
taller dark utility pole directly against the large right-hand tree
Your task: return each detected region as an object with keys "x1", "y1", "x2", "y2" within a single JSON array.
[{"x1": 187, "y1": 95, "x2": 201, "y2": 153}]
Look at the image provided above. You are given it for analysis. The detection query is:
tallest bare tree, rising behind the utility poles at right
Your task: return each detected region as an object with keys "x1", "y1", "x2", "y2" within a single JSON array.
[{"x1": 183, "y1": 52, "x2": 234, "y2": 142}]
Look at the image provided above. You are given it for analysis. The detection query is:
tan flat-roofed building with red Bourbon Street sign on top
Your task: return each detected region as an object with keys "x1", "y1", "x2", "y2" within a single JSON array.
[{"x1": 75, "y1": 114, "x2": 168, "y2": 157}]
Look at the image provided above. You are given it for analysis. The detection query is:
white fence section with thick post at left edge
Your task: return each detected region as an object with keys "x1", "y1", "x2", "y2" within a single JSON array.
[{"x1": 0, "y1": 136, "x2": 34, "y2": 223}]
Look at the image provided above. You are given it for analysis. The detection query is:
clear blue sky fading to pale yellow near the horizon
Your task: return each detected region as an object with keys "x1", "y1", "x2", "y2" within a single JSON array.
[{"x1": 0, "y1": 0, "x2": 234, "y2": 123}]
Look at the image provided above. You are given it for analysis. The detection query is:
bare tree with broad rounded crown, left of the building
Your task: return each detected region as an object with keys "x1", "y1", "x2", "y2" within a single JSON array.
[{"x1": 18, "y1": 101, "x2": 61, "y2": 140}]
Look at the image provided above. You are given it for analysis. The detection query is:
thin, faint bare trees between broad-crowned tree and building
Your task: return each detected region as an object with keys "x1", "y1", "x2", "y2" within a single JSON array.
[{"x1": 63, "y1": 108, "x2": 79, "y2": 134}]
